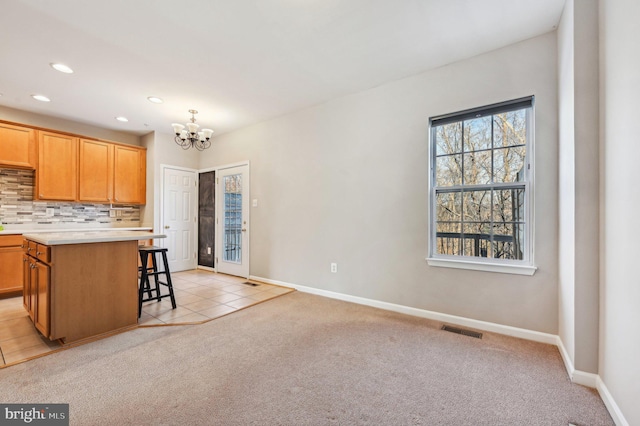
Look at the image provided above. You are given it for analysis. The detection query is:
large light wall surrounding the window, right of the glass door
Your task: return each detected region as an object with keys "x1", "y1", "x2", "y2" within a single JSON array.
[{"x1": 200, "y1": 32, "x2": 558, "y2": 334}]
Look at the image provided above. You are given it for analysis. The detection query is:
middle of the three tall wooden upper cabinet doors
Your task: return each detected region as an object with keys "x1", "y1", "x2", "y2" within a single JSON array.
[{"x1": 78, "y1": 139, "x2": 113, "y2": 203}]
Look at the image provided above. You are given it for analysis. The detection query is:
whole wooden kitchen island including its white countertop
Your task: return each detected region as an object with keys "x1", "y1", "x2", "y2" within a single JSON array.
[{"x1": 22, "y1": 231, "x2": 165, "y2": 344}]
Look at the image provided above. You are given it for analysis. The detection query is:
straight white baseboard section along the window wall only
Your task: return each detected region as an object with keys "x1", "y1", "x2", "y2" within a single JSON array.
[{"x1": 250, "y1": 275, "x2": 556, "y2": 346}]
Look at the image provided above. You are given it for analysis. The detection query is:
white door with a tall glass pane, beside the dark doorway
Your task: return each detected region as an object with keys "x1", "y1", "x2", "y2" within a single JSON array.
[{"x1": 216, "y1": 165, "x2": 249, "y2": 278}]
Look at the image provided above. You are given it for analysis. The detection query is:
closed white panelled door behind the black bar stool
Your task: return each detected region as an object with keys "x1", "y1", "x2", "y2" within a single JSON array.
[{"x1": 162, "y1": 167, "x2": 198, "y2": 271}]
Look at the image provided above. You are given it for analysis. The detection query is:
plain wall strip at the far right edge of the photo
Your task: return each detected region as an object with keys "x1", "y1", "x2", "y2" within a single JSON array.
[{"x1": 600, "y1": 0, "x2": 640, "y2": 425}]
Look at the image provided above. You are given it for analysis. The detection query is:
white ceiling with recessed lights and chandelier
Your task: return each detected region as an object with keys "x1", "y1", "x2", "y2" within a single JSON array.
[{"x1": 0, "y1": 0, "x2": 565, "y2": 136}]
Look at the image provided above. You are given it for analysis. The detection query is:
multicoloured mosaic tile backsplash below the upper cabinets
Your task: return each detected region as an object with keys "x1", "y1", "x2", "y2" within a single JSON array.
[{"x1": 0, "y1": 168, "x2": 140, "y2": 229}]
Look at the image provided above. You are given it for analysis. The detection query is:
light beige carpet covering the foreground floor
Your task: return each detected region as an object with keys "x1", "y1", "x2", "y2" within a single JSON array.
[{"x1": 0, "y1": 292, "x2": 613, "y2": 426}]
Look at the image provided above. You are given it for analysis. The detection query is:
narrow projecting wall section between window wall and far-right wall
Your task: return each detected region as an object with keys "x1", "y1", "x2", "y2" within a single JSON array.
[{"x1": 558, "y1": 0, "x2": 600, "y2": 373}]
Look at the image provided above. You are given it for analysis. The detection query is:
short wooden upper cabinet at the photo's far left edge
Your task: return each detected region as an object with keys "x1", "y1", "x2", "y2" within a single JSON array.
[{"x1": 0, "y1": 123, "x2": 38, "y2": 169}]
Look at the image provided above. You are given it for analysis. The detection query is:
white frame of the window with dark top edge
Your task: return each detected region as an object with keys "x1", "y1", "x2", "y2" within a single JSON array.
[{"x1": 426, "y1": 96, "x2": 537, "y2": 275}]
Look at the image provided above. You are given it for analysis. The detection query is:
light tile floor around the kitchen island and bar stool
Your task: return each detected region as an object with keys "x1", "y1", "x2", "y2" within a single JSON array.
[{"x1": 0, "y1": 269, "x2": 294, "y2": 368}]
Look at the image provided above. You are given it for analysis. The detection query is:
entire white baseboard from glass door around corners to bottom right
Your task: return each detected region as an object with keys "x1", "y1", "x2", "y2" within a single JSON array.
[{"x1": 249, "y1": 275, "x2": 629, "y2": 426}]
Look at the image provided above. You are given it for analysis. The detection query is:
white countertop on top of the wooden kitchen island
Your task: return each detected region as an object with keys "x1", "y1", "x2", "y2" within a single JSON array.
[{"x1": 22, "y1": 230, "x2": 166, "y2": 246}]
